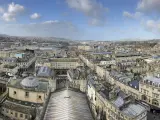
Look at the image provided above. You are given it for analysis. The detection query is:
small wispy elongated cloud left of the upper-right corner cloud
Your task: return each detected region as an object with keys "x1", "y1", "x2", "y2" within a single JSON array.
[{"x1": 123, "y1": 11, "x2": 142, "y2": 19}]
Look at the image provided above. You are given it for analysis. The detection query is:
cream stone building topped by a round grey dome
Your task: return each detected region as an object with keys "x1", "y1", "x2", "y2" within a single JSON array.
[{"x1": 1, "y1": 76, "x2": 48, "y2": 120}]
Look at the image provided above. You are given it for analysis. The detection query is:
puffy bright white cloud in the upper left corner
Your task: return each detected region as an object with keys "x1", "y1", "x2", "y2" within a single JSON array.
[{"x1": 1, "y1": 3, "x2": 25, "y2": 22}]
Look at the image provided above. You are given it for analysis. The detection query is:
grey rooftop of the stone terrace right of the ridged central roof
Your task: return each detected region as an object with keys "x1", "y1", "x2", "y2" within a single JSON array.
[{"x1": 89, "y1": 77, "x2": 146, "y2": 118}]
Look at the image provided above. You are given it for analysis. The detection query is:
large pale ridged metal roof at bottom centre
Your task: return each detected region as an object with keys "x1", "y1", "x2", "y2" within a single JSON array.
[{"x1": 44, "y1": 90, "x2": 93, "y2": 120}]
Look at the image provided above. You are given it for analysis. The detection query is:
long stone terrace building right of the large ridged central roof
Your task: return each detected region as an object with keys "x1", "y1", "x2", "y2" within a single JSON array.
[{"x1": 87, "y1": 80, "x2": 147, "y2": 120}]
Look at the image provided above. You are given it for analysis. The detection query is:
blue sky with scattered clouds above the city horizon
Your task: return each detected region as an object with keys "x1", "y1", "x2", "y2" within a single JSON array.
[{"x1": 0, "y1": 0, "x2": 160, "y2": 41}]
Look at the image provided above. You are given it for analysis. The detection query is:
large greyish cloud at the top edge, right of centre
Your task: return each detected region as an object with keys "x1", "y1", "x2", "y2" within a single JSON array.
[{"x1": 66, "y1": 0, "x2": 108, "y2": 25}]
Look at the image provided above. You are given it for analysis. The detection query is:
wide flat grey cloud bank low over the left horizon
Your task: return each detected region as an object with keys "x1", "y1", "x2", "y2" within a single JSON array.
[{"x1": 0, "y1": 20, "x2": 81, "y2": 39}]
